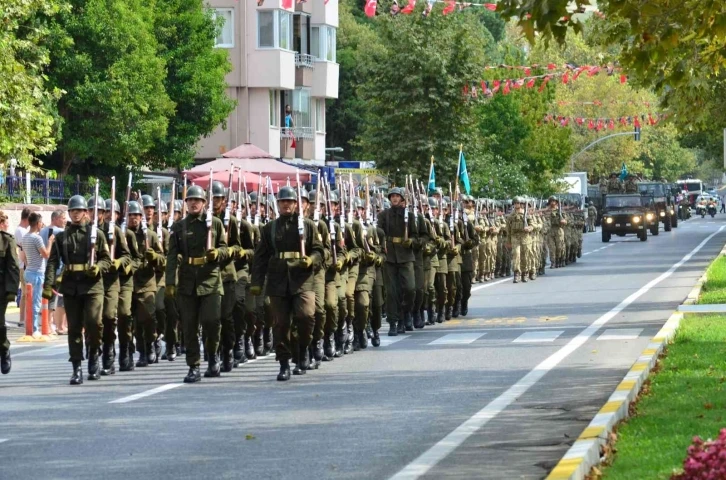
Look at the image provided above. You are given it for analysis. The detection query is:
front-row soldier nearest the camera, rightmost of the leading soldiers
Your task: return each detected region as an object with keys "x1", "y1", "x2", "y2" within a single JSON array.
[{"x1": 250, "y1": 187, "x2": 325, "y2": 381}]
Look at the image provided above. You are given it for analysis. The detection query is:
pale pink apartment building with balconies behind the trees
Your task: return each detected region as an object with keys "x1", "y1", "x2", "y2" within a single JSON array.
[{"x1": 197, "y1": 0, "x2": 339, "y2": 164}]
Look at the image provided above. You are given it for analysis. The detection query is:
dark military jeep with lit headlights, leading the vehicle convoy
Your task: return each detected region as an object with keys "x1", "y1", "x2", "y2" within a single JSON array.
[{"x1": 600, "y1": 193, "x2": 658, "y2": 243}]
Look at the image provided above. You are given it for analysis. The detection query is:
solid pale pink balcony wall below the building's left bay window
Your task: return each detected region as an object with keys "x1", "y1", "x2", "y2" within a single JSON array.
[{"x1": 247, "y1": 48, "x2": 295, "y2": 90}]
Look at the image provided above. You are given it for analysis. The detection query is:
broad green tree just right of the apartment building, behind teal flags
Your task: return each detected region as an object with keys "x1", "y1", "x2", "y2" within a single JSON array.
[{"x1": 359, "y1": 10, "x2": 493, "y2": 183}]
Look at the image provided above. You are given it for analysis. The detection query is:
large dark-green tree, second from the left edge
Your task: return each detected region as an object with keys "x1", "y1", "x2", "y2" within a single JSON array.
[{"x1": 48, "y1": 0, "x2": 174, "y2": 174}]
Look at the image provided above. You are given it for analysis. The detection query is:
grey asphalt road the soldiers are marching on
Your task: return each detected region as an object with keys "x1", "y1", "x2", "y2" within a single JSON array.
[{"x1": 0, "y1": 216, "x2": 726, "y2": 480}]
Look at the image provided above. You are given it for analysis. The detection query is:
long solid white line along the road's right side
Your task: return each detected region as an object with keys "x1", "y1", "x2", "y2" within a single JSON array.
[{"x1": 391, "y1": 225, "x2": 726, "y2": 480}]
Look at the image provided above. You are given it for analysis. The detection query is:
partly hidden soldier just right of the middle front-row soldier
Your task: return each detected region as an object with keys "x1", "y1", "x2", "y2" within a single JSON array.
[{"x1": 212, "y1": 180, "x2": 244, "y2": 372}]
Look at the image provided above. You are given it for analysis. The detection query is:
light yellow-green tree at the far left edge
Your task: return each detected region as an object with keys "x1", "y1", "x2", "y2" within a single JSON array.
[{"x1": 0, "y1": 0, "x2": 64, "y2": 167}]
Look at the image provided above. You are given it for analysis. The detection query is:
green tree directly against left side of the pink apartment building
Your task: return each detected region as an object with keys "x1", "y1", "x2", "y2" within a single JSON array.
[{"x1": 143, "y1": 0, "x2": 235, "y2": 168}]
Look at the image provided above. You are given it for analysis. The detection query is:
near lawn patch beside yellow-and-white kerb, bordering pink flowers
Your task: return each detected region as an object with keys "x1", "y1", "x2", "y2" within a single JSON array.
[{"x1": 603, "y1": 316, "x2": 726, "y2": 480}]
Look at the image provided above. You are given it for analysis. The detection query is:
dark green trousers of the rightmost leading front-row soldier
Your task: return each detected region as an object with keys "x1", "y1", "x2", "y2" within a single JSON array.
[{"x1": 270, "y1": 292, "x2": 315, "y2": 361}]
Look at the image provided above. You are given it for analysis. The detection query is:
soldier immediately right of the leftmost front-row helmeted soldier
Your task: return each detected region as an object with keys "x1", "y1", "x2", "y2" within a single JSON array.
[{"x1": 95, "y1": 198, "x2": 131, "y2": 375}]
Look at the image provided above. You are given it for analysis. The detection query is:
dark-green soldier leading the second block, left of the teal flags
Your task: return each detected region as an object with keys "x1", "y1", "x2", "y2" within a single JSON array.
[{"x1": 378, "y1": 187, "x2": 417, "y2": 336}]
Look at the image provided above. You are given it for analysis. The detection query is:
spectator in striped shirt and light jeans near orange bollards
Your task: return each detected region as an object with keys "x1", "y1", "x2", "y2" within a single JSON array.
[{"x1": 22, "y1": 212, "x2": 54, "y2": 338}]
